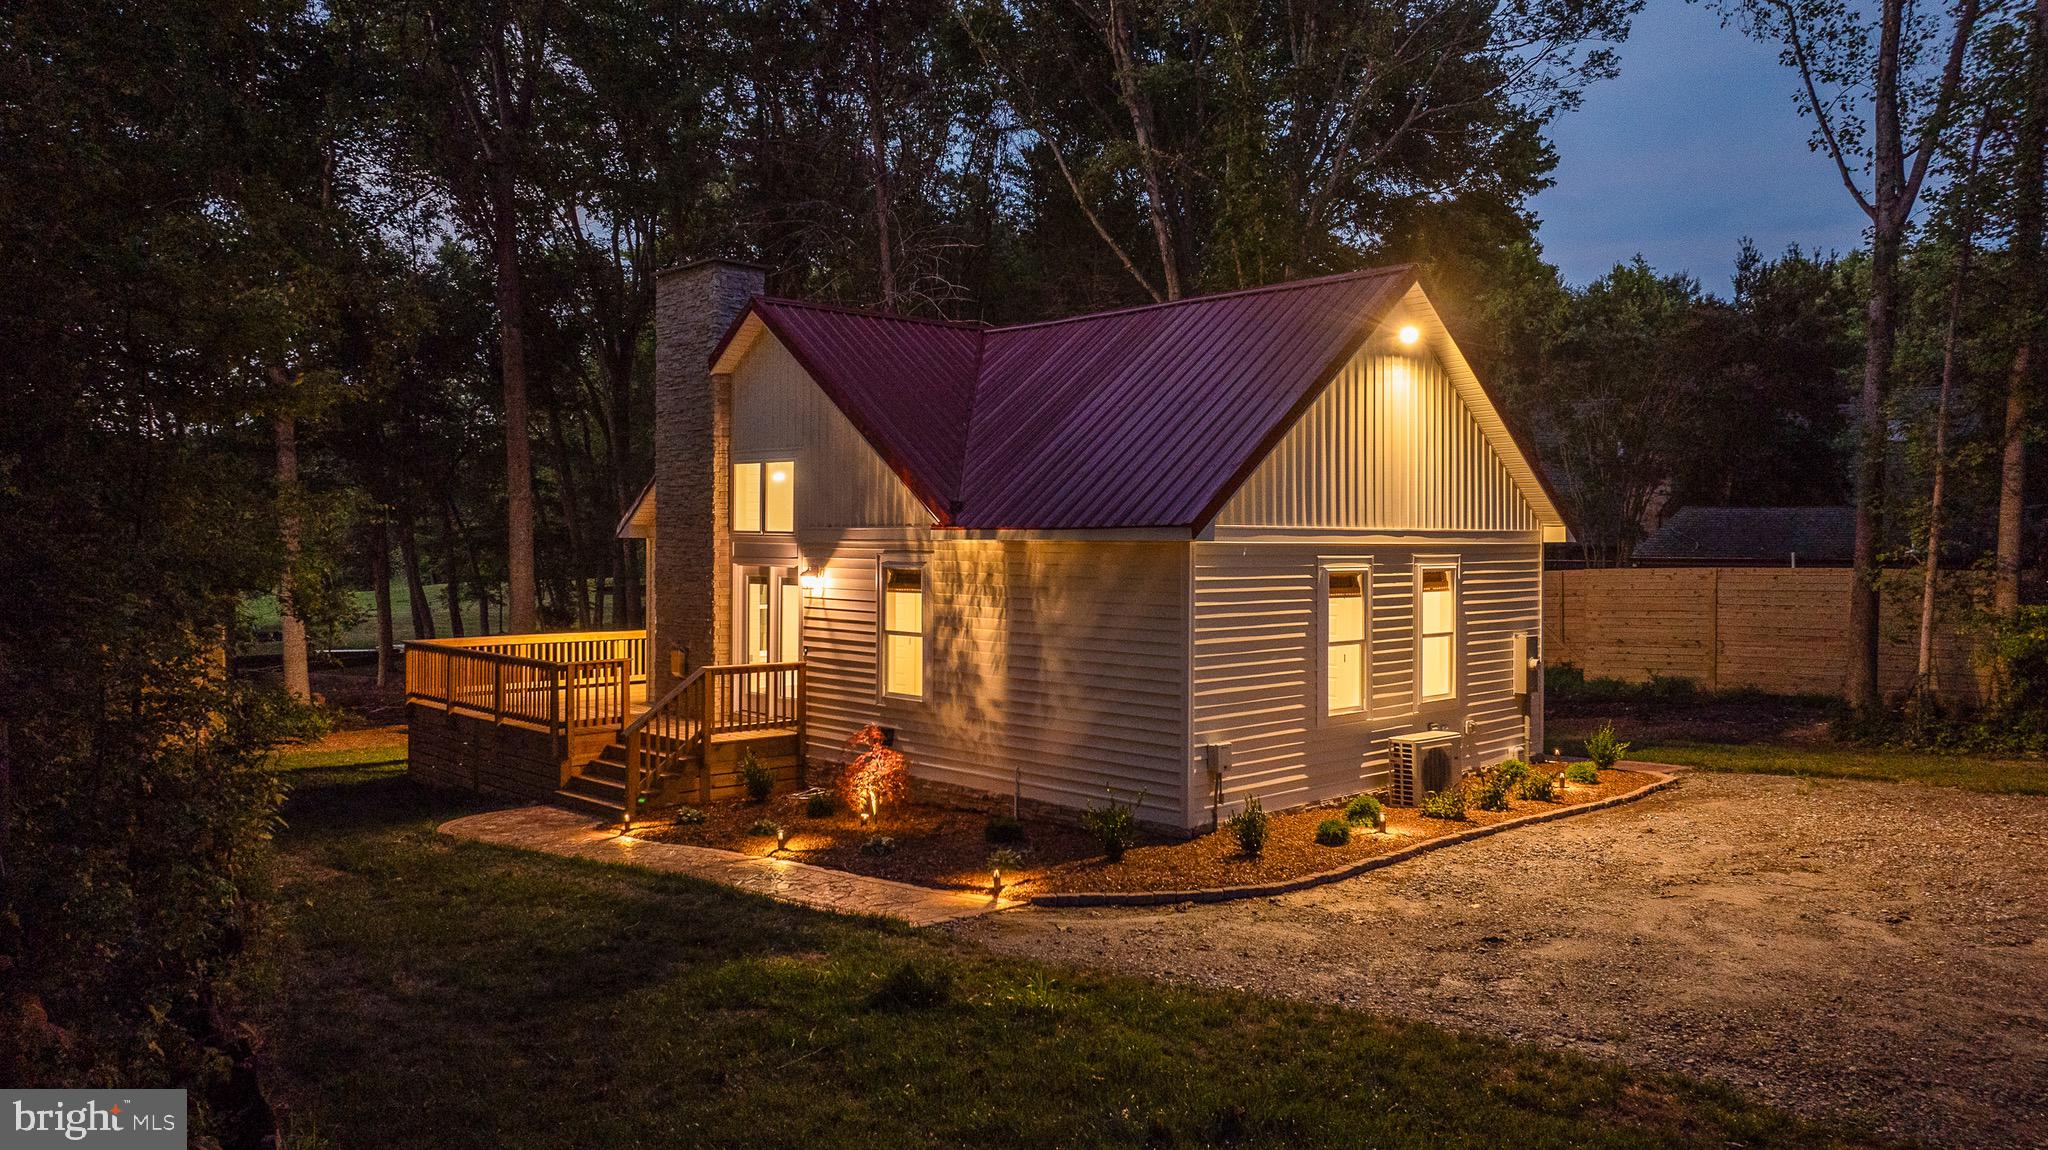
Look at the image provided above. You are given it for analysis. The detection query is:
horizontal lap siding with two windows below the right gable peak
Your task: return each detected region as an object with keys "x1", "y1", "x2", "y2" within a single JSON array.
[{"x1": 1190, "y1": 530, "x2": 1542, "y2": 825}]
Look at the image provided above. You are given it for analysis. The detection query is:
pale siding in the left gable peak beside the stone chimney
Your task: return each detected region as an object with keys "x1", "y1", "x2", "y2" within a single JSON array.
[{"x1": 731, "y1": 334, "x2": 932, "y2": 530}]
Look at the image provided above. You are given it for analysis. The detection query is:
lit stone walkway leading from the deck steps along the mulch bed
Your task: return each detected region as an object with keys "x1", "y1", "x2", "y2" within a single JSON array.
[{"x1": 440, "y1": 806, "x2": 1018, "y2": 927}]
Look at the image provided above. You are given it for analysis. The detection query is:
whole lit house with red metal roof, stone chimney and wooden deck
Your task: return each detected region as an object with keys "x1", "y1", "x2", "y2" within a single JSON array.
[{"x1": 408, "y1": 260, "x2": 1567, "y2": 829}]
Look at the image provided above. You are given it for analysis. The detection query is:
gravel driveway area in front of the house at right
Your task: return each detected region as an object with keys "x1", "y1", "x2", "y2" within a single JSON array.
[{"x1": 954, "y1": 773, "x2": 2048, "y2": 1146}]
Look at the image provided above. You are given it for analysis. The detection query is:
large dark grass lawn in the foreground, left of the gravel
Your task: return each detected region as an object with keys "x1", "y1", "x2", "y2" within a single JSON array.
[{"x1": 238, "y1": 767, "x2": 1875, "y2": 1148}]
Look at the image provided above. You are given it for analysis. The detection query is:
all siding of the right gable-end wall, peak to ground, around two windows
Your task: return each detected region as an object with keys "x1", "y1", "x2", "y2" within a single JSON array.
[{"x1": 1190, "y1": 340, "x2": 1542, "y2": 825}]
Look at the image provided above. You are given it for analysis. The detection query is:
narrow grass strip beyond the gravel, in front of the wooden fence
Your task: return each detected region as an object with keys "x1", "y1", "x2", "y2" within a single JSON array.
[{"x1": 1628, "y1": 743, "x2": 2048, "y2": 794}]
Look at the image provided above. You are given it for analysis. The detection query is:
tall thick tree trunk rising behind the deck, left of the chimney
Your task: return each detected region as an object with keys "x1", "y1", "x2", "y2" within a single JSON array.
[{"x1": 492, "y1": 162, "x2": 537, "y2": 634}]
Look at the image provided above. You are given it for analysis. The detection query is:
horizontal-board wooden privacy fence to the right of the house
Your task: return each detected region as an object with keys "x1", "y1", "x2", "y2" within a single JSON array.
[{"x1": 1542, "y1": 567, "x2": 1982, "y2": 700}]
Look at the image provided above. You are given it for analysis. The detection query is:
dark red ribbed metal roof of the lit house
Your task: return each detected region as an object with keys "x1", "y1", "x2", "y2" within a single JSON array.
[{"x1": 711, "y1": 264, "x2": 1563, "y2": 530}]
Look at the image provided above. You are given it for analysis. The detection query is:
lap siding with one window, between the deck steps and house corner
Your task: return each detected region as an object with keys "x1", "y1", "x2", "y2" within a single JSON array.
[{"x1": 782, "y1": 532, "x2": 1188, "y2": 825}]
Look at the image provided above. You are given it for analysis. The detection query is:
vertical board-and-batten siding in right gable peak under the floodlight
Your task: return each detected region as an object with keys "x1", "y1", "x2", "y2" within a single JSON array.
[{"x1": 1217, "y1": 348, "x2": 1538, "y2": 532}]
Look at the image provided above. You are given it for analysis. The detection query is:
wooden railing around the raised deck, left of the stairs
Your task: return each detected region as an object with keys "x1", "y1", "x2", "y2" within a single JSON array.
[{"x1": 406, "y1": 630, "x2": 647, "y2": 737}]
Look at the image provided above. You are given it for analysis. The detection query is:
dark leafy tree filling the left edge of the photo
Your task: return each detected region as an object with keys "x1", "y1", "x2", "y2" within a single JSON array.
[{"x1": 0, "y1": 2, "x2": 335, "y2": 1144}]
